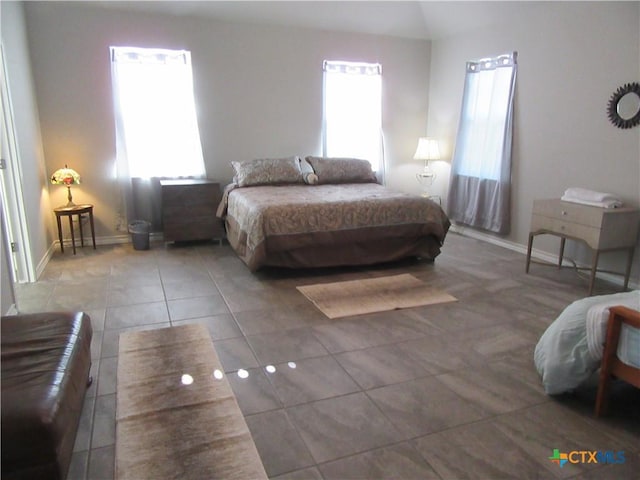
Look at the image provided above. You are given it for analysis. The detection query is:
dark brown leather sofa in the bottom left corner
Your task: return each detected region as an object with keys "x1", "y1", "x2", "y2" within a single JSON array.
[{"x1": 0, "y1": 312, "x2": 93, "y2": 480}]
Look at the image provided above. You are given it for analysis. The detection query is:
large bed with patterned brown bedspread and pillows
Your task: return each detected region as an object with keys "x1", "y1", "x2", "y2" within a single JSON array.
[{"x1": 218, "y1": 157, "x2": 450, "y2": 271}]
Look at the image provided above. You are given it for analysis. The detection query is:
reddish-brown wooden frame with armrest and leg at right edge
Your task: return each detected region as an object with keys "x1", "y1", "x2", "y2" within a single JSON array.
[{"x1": 595, "y1": 306, "x2": 640, "y2": 417}]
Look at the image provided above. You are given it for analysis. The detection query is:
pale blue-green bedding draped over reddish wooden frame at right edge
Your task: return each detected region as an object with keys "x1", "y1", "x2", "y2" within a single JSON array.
[{"x1": 534, "y1": 290, "x2": 640, "y2": 395}]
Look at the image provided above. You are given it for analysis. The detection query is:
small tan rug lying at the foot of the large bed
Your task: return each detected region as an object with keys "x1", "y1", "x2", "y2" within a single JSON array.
[{"x1": 296, "y1": 273, "x2": 457, "y2": 318}]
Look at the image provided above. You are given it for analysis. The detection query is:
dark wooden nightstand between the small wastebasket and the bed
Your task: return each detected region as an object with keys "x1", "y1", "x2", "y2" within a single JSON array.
[{"x1": 160, "y1": 179, "x2": 225, "y2": 242}]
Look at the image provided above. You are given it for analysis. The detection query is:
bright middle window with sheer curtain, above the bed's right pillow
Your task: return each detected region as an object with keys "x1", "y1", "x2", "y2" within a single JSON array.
[{"x1": 323, "y1": 61, "x2": 382, "y2": 171}]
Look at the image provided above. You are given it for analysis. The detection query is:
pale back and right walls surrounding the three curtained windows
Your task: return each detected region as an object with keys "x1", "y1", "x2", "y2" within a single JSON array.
[{"x1": 10, "y1": 2, "x2": 640, "y2": 281}]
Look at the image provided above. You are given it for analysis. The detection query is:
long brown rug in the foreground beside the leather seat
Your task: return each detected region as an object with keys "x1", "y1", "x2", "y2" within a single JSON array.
[{"x1": 115, "y1": 324, "x2": 267, "y2": 480}]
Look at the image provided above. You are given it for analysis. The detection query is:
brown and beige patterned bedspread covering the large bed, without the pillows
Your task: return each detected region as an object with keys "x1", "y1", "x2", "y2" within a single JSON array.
[{"x1": 220, "y1": 183, "x2": 450, "y2": 270}]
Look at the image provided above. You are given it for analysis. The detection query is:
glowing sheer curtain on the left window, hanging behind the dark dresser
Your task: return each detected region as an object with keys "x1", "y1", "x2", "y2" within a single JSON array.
[{"x1": 110, "y1": 47, "x2": 206, "y2": 231}]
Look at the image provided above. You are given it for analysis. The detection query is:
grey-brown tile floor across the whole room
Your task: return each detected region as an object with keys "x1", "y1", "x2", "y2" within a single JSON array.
[{"x1": 12, "y1": 233, "x2": 640, "y2": 480}]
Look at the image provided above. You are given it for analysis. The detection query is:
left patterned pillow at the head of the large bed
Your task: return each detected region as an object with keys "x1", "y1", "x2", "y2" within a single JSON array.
[{"x1": 231, "y1": 156, "x2": 304, "y2": 187}]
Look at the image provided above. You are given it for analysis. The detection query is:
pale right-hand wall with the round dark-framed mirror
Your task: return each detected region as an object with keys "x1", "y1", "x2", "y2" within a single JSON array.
[{"x1": 428, "y1": 2, "x2": 640, "y2": 282}]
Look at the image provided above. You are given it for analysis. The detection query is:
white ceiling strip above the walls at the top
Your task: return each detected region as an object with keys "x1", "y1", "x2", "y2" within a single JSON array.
[{"x1": 93, "y1": 0, "x2": 547, "y2": 39}]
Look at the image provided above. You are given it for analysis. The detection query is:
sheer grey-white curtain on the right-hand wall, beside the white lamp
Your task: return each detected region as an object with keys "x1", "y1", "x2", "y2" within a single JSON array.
[{"x1": 448, "y1": 52, "x2": 517, "y2": 235}]
